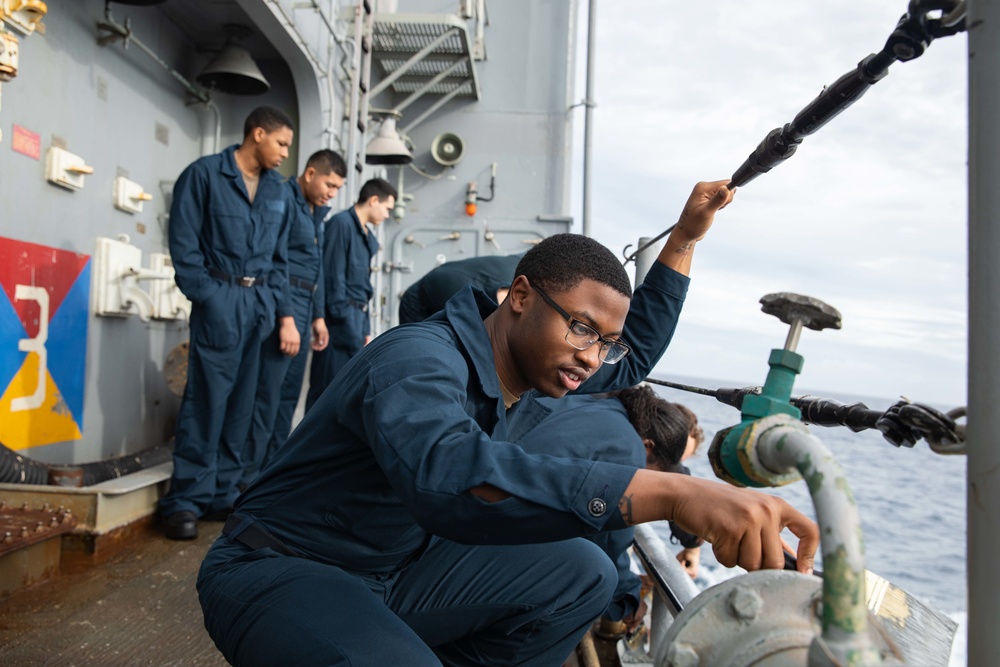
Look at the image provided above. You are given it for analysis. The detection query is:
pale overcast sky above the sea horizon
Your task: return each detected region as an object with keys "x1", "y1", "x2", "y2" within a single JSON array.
[{"x1": 574, "y1": 0, "x2": 968, "y2": 407}]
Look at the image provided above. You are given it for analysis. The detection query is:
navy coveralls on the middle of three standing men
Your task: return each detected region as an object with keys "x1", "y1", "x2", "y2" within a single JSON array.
[{"x1": 242, "y1": 179, "x2": 330, "y2": 484}]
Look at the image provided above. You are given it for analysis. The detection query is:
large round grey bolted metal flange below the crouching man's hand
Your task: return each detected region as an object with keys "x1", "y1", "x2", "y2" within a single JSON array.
[{"x1": 653, "y1": 570, "x2": 899, "y2": 667}]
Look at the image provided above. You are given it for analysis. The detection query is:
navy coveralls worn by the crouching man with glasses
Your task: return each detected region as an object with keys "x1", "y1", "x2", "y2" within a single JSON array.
[{"x1": 198, "y1": 263, "x2": 688, "y2": 667}]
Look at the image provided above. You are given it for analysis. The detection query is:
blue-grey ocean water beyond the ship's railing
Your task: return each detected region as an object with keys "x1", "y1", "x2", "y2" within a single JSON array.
[{"x1": 654, "y1": 376, "x2": 967, "y2": 666}]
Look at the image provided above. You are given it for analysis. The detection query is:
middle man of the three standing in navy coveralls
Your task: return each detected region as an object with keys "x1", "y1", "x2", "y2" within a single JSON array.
[{"x1": 241, "y1": 149, "x2": 347, "y2": 486}]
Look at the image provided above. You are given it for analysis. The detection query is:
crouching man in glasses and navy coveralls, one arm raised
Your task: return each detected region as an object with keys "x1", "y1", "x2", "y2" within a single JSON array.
[{"x1": 198, "y1": 181, "x2": 818, "y2": 667}]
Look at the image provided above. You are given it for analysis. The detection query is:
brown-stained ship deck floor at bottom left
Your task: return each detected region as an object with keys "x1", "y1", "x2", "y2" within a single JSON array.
[{"x1": 0, "y1": 521, "x2": 229, "y2": 667}]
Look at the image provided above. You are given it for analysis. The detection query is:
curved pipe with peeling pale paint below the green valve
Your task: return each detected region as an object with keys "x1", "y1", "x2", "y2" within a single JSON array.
[{"x1": 741, "y1": 414, "x2": 882, "y2": 665}]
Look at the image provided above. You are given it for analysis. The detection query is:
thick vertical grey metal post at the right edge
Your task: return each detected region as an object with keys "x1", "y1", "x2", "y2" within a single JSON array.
[{"x1": 966, "y1": 0, "x2": 1000, "y2": 667}]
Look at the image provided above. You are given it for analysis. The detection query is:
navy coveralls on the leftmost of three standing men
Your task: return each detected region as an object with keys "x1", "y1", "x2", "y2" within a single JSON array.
[{"x1": 160, "y1": 146, "x2": 289, "y2": 516}]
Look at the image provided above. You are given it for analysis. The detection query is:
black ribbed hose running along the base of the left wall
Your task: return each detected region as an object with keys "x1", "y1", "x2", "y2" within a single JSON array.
[{"x1": 0, "y1": 442, "x2": 174, "y2": 486}]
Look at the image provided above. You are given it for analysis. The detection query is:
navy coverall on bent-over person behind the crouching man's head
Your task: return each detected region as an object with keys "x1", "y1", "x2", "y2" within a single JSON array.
[{"x1": 399, "y1": 254, "x2": 524, "y2": 324}]
